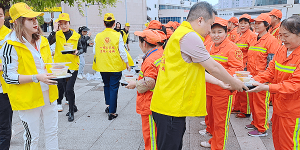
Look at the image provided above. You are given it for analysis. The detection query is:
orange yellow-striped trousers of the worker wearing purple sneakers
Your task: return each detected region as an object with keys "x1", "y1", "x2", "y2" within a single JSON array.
[{"x1": 249, "y1": 91, "x2": 270, "y2": 132}]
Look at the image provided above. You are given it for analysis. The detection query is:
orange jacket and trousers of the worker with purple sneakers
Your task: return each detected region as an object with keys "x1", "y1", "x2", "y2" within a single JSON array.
[{"x1": 247, "y1": 33, "x2": 280, "y2": 132}]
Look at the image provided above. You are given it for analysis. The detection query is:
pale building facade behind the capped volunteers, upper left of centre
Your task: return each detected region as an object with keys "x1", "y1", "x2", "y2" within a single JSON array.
[{"x1": 61, "y1": 0, "x2": 147, "y2": 35}]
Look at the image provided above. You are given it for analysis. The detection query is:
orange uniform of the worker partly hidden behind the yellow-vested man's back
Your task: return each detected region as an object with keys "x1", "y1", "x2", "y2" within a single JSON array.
[{"x1": 136, "y1": 47, "x2": 163, "y2": 150}]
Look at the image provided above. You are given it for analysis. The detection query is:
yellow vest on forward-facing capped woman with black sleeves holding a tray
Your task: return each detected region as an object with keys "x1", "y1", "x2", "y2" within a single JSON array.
[{"x1": 53, "y1": 29, "x2": 80, "y2": 70}]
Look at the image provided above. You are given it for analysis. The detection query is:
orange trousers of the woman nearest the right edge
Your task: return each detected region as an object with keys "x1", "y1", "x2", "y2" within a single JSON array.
[{"x1": 272, "y1": 114, "x2": 300, "y2": 150}]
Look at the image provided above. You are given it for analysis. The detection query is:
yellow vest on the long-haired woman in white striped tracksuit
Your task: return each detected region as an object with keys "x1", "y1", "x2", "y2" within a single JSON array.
[{"x1": 7, "y1": 37, "x2": 58, "y2": 110}]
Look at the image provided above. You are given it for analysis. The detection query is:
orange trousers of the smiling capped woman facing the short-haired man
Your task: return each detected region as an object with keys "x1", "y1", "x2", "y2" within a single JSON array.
[{"x1": 206, "y1": 95, "x2": 233, "y2": 150}]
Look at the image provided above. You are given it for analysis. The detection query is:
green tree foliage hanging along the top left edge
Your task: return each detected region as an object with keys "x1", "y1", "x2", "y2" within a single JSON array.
[{"x1": 0, "y1": 0, "x2": 117, "y2": 13}]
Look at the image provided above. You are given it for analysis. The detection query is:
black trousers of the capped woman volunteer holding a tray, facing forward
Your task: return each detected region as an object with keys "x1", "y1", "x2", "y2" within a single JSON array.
[{"x1": 57, "y1": 70, "x2": 78, "y2": 112}]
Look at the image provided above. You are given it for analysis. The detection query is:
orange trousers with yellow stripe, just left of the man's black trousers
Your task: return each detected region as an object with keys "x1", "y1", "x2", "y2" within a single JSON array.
[{"x1": 141, "y1": 115, "x2": 157, "y2": 150}]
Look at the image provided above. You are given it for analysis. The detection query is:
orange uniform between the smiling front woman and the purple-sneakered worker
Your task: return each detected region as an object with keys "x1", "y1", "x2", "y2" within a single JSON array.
[{"x1": 233, "y1": 29, "x2": 257, "y2": 114}]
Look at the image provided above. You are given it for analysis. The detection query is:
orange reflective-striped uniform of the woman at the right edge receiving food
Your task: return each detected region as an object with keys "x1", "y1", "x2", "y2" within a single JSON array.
[{"x1": 254, "y1": 45, "x2": 300, "y2": 150}]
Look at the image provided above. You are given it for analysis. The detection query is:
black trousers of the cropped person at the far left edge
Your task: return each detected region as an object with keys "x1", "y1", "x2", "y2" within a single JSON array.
[{"x1": 0, "y1": 93, "x2": 13, "y2": 150}]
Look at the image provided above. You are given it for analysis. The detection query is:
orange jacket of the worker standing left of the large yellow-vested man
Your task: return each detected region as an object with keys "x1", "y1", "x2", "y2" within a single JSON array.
[{"x1": 136, "y1": 47, "x2": 164, "y2": 115}]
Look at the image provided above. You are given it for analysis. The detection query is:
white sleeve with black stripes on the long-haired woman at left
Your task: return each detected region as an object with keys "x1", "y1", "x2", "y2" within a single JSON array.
[{"x1": 1, "y1": 43, "x2": 20, "y2": 84}]
